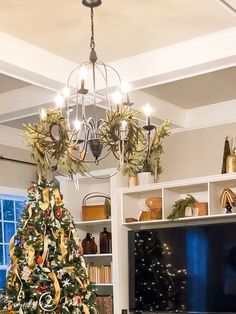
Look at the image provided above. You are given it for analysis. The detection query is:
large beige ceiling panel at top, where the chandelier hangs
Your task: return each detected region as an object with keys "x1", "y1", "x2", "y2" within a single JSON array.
[{"x1": 0, "y1": 0, "x2": 236, "y2": 62}]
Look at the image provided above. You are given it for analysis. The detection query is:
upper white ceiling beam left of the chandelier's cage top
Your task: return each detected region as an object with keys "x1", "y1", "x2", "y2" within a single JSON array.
[{"x1": 0, "y1": 32, "x2": 77, "y2": 90}]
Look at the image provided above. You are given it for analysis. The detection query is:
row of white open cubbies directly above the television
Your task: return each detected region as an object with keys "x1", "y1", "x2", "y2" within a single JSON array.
[{"x1": 120, "y1": 173, "x2": 236, "y2": 227}]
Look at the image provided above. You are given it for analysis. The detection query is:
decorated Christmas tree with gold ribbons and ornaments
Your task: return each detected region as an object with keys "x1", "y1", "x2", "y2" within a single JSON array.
[{"x1": 0, "y1": 180, "x2": 96, "y2": 314}]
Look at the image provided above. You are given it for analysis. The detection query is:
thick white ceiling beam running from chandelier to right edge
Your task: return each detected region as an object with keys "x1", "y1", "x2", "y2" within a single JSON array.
[{"x1": 111, "y1": 27, "x2": 236, "y2": 89}]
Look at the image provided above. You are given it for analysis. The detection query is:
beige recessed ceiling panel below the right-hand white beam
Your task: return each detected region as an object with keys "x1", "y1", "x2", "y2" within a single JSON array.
[{"x1": 143, "y1": 67, "x2": 236, "y2": 109}]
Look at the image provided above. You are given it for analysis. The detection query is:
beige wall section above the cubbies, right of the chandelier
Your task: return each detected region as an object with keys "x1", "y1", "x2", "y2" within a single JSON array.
[{"x1": 159, "y1": 123, "x2": 236, "y2": 181}]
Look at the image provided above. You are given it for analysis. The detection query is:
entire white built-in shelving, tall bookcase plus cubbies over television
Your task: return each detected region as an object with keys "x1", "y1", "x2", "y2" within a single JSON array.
[{"x1": 60, "y1": 169, "x2": 236, "y2": 314}]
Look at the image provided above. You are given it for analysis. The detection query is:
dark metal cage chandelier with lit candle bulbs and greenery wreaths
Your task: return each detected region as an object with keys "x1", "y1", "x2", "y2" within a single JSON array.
[{"x1": 24, "y1": 0, "x2": 169, "y2": 182}]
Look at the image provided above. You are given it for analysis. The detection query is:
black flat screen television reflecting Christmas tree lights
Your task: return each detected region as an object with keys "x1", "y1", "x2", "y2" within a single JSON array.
[{"x1": 128, "y1": 222, "x2": 236, "y2": 314}]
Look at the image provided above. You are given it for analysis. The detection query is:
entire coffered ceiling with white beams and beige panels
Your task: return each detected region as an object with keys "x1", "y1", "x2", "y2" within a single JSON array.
[{"x1": 0, "y1": 0, "x2": 236, "y2": 140}]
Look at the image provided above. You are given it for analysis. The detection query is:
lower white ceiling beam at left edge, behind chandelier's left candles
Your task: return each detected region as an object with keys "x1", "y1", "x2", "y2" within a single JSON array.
[{"x1": 0, "y1": 85, "x2": 56, "y2": 123}]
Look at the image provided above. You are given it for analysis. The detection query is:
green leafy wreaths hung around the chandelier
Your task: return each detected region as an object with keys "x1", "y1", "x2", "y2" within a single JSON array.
[{"x1": 23, "y1": 105, "x2": 170, "y2": 176}]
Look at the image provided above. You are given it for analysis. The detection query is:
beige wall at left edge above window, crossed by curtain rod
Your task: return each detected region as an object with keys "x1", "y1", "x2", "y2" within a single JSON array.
[{"x1": 0, "y1": 145, "x2": 36, "y2": 189}]
